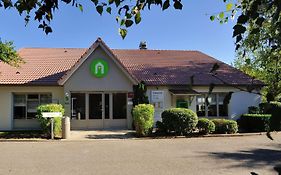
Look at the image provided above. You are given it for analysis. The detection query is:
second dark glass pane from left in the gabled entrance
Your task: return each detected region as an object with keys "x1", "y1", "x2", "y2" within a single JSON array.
[{"x1": 89, "y1": 94, "x2": 102, "y2": 119}]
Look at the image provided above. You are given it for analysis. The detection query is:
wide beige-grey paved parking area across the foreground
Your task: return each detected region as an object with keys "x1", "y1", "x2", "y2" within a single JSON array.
[{"x1": 0, "y1": 133, "x2": 281, "y2": 175}]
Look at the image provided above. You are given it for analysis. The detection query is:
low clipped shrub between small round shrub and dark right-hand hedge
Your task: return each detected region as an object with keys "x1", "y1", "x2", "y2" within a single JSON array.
[{"x1": 211, "y1": 119, "x2": 238, "y2": 134}]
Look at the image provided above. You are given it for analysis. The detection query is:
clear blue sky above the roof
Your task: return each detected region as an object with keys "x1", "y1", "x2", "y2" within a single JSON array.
[{"x1": 0, "y1": 0, "x2": 235, "y2": 63}]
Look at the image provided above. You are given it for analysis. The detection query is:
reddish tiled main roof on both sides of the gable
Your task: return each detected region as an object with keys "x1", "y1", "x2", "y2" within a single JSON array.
[{"x1": 0, "y1": 42, "x2": 263, "y2": 85}]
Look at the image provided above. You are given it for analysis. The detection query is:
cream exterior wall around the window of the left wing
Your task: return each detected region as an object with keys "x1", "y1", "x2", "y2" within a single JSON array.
[{"x1": 0, "y1": 86, "x2": 63, "y2": 130}]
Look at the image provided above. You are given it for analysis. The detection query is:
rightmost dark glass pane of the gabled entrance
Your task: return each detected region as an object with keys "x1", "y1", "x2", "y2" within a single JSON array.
[{"x1": 113, "y1": 93, "x2": 127, "y2": 119}]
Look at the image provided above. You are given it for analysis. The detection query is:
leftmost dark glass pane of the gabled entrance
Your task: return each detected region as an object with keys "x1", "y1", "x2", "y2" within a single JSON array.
[{"x1": 71, "y1": 93, "x2": 86, "y2": 120}]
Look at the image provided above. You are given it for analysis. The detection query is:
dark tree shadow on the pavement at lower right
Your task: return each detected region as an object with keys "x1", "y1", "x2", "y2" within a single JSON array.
[{"x1": 207, "y1": 145, "x2": 281, "y2": 175}]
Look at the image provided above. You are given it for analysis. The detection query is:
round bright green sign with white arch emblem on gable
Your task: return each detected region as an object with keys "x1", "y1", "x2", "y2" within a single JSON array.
[{"x1": 90, "y1": 59, "x2": 108, "y2": 78}]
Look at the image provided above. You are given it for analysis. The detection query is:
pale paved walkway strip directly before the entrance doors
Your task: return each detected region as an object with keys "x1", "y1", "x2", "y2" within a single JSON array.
[{"x1": 69, "y1": 130, "x2": 134, "y2": 140}]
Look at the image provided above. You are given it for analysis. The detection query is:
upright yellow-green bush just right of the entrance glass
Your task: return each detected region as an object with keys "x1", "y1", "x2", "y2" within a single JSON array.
[{"x1": 133, "y1": 104, "x2": 154, "y2": 136}]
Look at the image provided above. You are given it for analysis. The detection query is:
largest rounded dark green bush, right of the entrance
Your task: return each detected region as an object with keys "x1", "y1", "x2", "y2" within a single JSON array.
[{"x1": 157, "y1": 108, "x2": 198, "y2": 135}]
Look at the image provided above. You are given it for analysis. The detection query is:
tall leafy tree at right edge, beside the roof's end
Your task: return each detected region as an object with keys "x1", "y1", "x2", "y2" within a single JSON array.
[{"x1": 231, "y1": 0, "x2": 281, "y2": 100}]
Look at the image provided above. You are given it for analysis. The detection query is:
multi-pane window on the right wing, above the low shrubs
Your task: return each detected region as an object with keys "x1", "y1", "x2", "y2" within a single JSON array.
[{"x1": 196, "y1": 93, "x2": 228, "y2": 117}]
